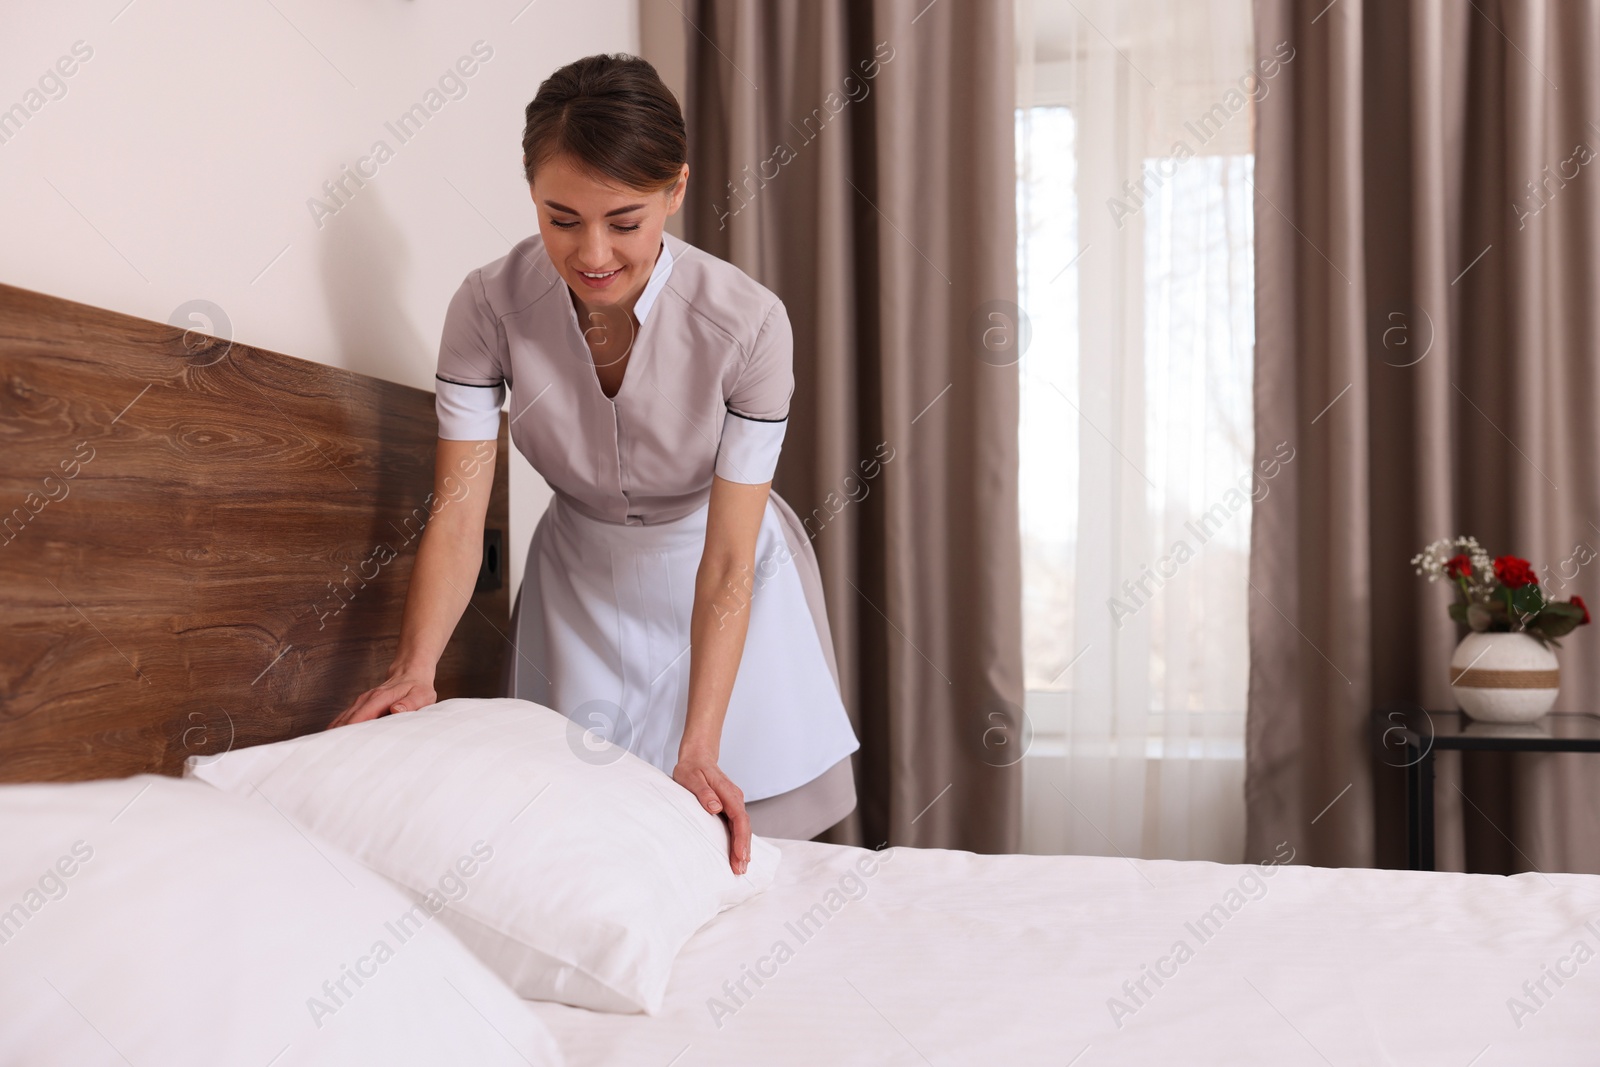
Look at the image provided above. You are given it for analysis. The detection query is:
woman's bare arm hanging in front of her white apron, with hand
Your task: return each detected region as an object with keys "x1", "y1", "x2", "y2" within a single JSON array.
[{"x1": 672, "y1": 477, "x2": 773, "y2": 875}]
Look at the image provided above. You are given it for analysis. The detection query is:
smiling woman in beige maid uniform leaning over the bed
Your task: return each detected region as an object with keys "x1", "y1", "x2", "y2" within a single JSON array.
[{"x1": 333, "y1": 54, "x2": 859, "y2": 873}]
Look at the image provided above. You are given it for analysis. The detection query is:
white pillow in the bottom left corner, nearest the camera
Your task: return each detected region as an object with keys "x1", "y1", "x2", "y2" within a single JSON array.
[{"x1": 0, "y1": 774, "x2": 563, "y2": 1067}]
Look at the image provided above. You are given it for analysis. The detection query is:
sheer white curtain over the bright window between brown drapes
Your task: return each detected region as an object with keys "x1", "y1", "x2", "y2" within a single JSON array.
[{"x1": 1016, "y1": 0, "x2": 1254, "y2": 862}]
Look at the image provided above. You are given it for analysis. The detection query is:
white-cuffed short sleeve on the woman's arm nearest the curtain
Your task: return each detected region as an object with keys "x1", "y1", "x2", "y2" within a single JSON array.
[{"x1": 717, "y1": 301, "x2": 795, "y2": 485}]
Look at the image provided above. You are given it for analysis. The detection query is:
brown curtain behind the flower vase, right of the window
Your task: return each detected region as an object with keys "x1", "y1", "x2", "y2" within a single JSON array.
[{"x1": 1246, "y1": 0, "x2": 1600, "y2": 872}]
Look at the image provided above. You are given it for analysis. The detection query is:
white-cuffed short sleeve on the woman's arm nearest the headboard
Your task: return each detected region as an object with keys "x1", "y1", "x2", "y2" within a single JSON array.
[{"x1": 434, "y1": 270, "x2": 507, "y2": 442}]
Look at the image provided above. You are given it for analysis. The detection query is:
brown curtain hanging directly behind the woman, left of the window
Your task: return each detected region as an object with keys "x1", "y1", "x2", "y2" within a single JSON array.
[{"x1": 685, "y1": 0, "x2": 1024, "y2": 853}]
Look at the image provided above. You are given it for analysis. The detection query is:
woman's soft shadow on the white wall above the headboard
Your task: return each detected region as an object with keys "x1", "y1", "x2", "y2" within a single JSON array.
[{"x1": 322, "y1": 186, "x2": 428, "y2": 389}]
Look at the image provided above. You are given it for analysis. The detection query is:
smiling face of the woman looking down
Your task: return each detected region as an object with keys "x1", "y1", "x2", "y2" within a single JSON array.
[{"x1": 530, "y1": 155, "x2": 690, "y2": 309}]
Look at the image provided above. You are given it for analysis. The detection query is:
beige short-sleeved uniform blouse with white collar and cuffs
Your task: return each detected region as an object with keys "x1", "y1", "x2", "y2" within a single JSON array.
[{"x1": 437, "y1": 234, "x2": 794, "y2": 511}]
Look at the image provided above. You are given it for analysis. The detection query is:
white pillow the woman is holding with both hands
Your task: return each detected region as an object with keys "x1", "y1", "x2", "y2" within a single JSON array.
[{"x1": 190, "y1": 699, "x2": 782, "y2": 1014}]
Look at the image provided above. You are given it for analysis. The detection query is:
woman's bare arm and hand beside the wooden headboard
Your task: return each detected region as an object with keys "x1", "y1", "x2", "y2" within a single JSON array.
[{"x1": 328, "y1": 438, "x2": 496, "y2": 729}]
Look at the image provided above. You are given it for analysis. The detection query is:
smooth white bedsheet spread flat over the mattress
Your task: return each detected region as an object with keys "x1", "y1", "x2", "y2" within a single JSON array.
[{"x1": 530, "y1": 840, "x2": 1600, "y2": 1067}]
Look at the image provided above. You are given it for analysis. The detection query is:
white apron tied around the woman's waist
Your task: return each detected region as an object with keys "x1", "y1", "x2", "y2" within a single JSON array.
[{"x1": 507, "y1": 494, "x2": 861, "y2": 801}]
